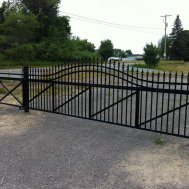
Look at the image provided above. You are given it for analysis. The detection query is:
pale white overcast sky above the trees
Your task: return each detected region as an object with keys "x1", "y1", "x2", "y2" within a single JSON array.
[{"x1": 59, "y1": 0, "x2": 189, "y2": 54}]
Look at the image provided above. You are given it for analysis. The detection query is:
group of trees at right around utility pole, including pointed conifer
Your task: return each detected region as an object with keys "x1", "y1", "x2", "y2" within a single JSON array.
[{"x1": 140, "y1": 15, "x2": 189, "y2": 66}]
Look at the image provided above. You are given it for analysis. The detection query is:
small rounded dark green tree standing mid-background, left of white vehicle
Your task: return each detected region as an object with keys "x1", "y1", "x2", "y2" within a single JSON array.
[{"x1": 98, "y1": 39, "x2": 114, "y2": 60}]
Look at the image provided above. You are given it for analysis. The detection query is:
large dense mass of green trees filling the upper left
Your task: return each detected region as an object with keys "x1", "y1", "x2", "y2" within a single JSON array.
[{"x1": 0, "y1": 0, "x2": 97, "y2": 61}]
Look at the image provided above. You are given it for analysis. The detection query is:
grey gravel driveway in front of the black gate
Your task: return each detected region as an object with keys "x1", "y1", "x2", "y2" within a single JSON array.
[{"x1": 0, "y1": 105, "x2": 189, "y2": 189}]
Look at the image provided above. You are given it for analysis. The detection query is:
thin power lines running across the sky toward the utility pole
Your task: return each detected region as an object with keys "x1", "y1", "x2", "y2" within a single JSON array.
[{"x1": 62, "y1": 12, "x2": 162, "y2": 36}]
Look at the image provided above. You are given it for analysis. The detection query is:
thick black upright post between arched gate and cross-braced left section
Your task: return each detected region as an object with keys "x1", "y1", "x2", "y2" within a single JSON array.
[{"x1": 22, "y1": 67, "x2": 29, "y2": 112}]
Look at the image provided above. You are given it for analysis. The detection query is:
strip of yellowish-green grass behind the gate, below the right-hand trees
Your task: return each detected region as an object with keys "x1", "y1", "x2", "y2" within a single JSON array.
[{"x1": 133, "y1": 60, "x2": 189, "y2": 73}]
